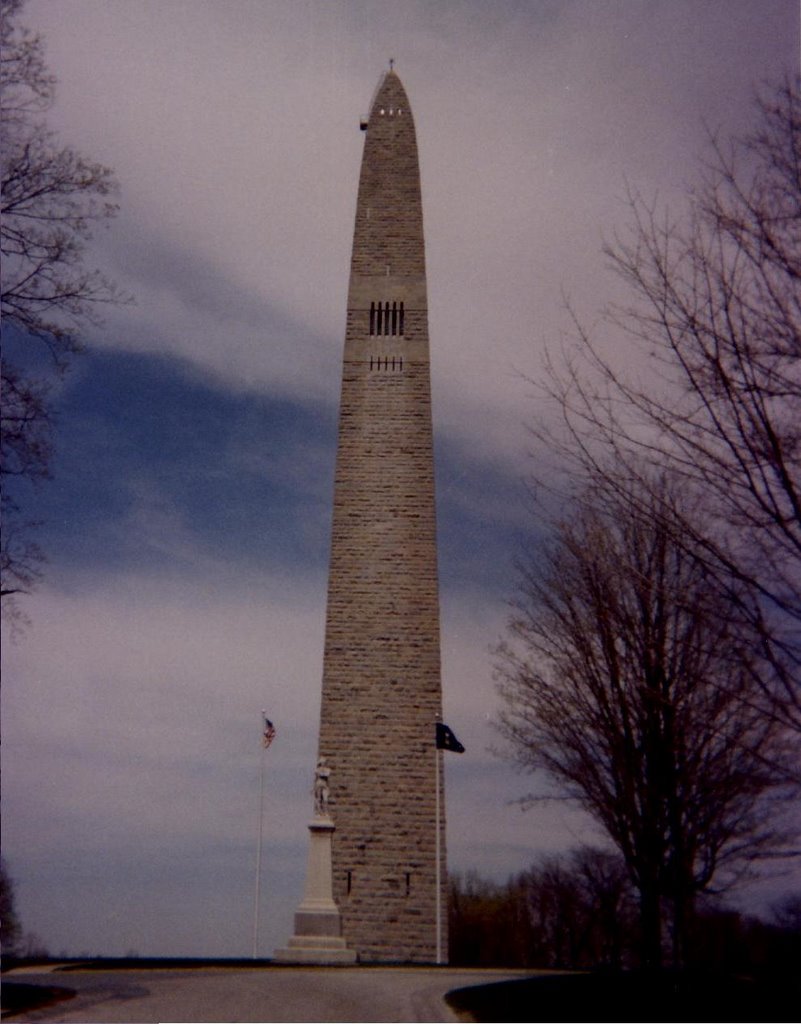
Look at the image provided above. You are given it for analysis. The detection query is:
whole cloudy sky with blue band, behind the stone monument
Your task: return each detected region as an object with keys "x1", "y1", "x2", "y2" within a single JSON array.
[{"x1": 3, "y1": 0, "x2": 799, "y2": 955}]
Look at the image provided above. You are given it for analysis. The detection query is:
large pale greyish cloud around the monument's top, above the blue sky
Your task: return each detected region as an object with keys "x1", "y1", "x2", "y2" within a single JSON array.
[{"x1": 30, "y1": 0, "x2": 798, "y2": 462}]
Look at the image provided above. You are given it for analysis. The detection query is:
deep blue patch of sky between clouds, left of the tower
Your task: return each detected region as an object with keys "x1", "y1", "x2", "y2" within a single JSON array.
[{"x1": 33, "y1": 350, "x2": 335, "y2": 575}]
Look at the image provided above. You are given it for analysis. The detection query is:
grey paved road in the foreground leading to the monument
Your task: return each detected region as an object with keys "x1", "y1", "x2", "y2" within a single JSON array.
[{"x1": 5, "y1": 967, "x2": 532, "y2": 1024}]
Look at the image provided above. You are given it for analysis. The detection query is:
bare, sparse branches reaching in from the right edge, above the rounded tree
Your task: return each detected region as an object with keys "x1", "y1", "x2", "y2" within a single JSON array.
[{"x1": 549, "y1": 79, "x2": 801, "y2": 728}]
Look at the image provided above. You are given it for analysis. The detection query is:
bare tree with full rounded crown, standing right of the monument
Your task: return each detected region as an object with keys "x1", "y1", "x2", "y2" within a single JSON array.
[{"x1": 499, "y1": 473, "x2": 792, "y2": 966}]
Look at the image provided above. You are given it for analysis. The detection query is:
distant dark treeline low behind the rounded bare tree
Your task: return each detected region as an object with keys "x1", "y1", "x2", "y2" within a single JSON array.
[{"x1": 449, "y1": 849, "x2": 801, "y2": 977}]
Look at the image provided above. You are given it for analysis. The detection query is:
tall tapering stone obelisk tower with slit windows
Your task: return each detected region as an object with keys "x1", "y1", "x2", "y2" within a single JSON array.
[{"x1": 320, "y1": 71, "x2": 448, "y2": 963}]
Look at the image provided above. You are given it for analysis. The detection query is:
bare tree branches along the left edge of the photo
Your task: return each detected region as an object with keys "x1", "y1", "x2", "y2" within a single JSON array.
[{"x1": 0, "y1": 0, "x2": 121, "y2": 596}]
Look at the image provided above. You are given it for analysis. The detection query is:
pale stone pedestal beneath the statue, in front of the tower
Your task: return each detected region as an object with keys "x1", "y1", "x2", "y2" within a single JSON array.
[{"x1": 273, "y1": 815, "x2": 356, "y2": 964}]
